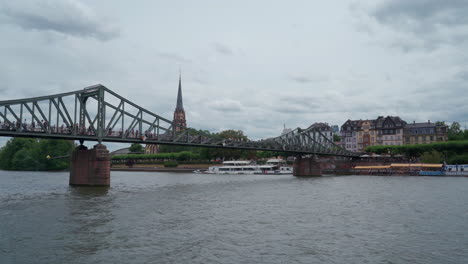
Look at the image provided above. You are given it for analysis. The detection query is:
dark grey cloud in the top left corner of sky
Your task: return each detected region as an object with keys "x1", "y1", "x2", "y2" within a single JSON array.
[{"x1": 0, "y1": 0, "x2": 119, "y2": 41}]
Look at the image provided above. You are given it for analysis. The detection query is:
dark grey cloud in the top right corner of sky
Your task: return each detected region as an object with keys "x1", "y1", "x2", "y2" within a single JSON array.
[{"x1": 370, "y1": 0, "x2": 468, "y2": 49}]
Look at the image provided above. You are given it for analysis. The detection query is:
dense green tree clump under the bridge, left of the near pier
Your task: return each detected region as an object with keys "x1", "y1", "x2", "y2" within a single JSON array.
[{"x1": 0, "y1": 138, "x2": 74, "y2": 171}]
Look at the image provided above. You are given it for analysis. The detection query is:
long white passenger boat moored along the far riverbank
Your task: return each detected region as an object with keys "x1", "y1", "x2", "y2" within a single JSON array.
[{"x1": 204, "y1": 160, "x2": 293, "y2": 174}]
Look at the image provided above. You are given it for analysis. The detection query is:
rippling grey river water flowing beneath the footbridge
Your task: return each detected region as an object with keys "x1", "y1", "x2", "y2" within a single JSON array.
[{"x1": 0, "y1": 171, "x2": 468, "y2": 264}]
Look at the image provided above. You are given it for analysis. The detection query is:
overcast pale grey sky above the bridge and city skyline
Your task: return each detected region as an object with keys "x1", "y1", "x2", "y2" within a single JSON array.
[{"x1": 0, "y1": 0, "x2": 468, "y2": 148}]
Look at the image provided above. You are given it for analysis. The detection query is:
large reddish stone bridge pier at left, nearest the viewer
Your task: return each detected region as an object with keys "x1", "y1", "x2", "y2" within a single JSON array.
[{"x1": 70, "y1": 144, "x2": 111, "y2": 186}]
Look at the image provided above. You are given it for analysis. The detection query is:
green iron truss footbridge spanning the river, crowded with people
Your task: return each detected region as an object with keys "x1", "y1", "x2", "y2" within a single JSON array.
[{"x1": 0, "y1": 84, "x2": 359, "y2": 157}]
